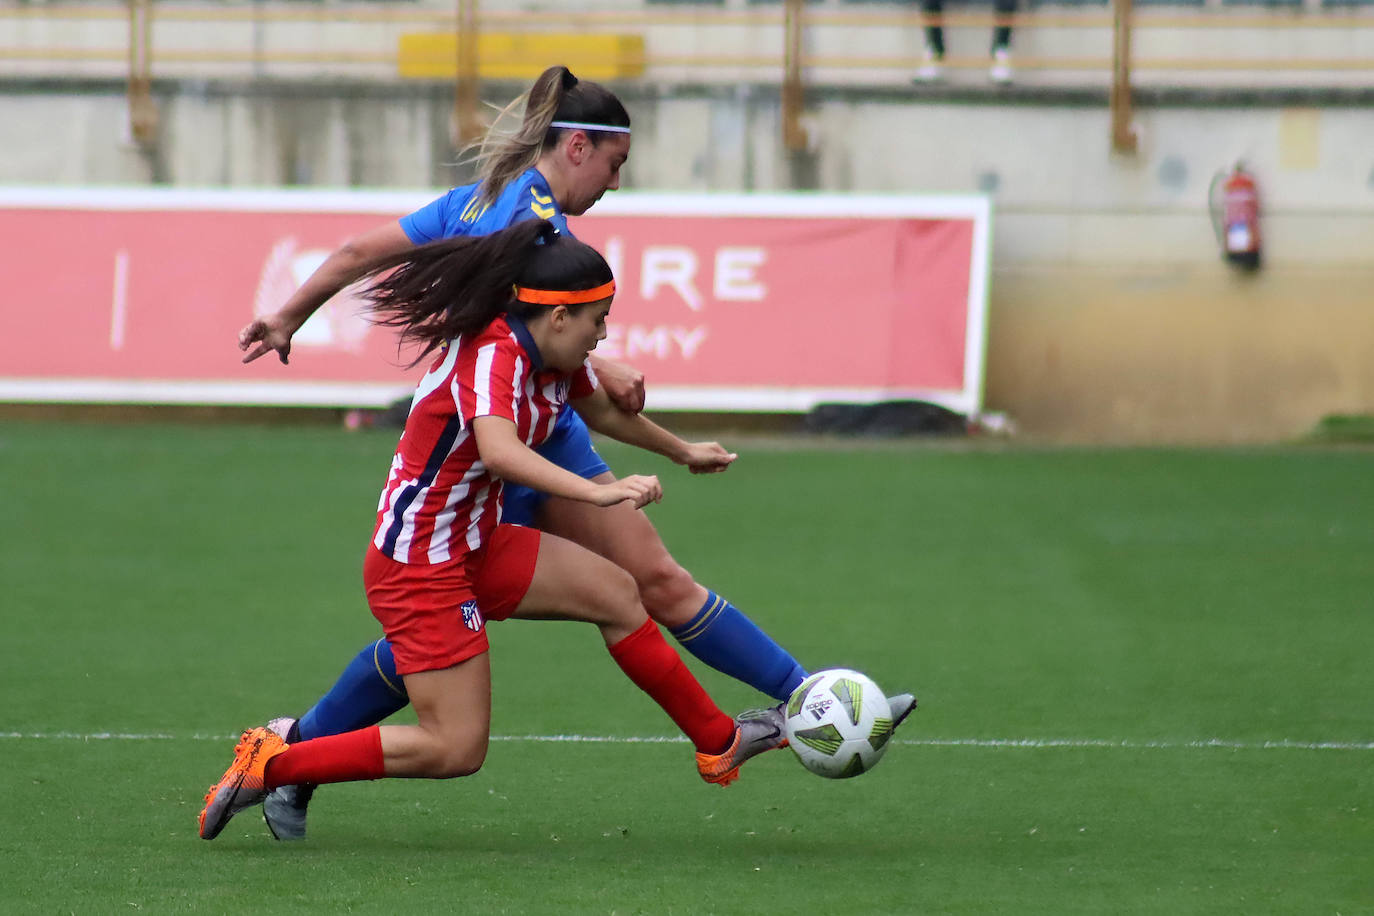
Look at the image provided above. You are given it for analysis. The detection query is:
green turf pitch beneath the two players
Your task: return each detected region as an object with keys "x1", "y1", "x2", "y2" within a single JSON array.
[{"x1": 0, "y1": 417, "x2": 1374, "y2": 913}]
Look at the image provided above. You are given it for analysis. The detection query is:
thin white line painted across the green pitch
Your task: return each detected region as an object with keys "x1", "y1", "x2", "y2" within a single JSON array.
[{"x1": 0, "y1": 732, "x2": 1374, "y2": 751}]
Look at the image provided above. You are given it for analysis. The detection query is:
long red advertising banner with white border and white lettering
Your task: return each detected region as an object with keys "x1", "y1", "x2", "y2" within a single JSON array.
[{"x1": 0, "y1": 190, "x2": 989, "y2": 413}]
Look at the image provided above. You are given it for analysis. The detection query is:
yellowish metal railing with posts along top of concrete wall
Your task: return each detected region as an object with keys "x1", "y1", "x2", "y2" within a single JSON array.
[{"x1": 0, "y1": 0, "x2": 1374, "y2": 150}]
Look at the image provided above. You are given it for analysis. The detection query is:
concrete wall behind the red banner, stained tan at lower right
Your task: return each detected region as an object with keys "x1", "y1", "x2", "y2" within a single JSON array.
[{"x1": 0, "y1": 76, "x2": 1374, "y2": 441}]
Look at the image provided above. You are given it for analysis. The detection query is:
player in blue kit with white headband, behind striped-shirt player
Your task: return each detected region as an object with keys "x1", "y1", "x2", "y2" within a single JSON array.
[{"x1": 239, "y1": 67, "x2": 915, "y2": 839}]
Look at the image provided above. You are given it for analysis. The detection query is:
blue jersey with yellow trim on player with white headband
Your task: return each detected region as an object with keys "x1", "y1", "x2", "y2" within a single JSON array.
[{"x1": 401, "y1": 168, "x2": 567, "y2": 244}]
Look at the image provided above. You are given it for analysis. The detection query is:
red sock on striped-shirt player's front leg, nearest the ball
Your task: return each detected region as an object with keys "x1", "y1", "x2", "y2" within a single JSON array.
[{"x1": 610, "y1": 621, "x2": 735, "y2": 754}]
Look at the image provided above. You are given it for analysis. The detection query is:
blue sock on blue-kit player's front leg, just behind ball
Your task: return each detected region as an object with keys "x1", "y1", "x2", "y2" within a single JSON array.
[{"x1": 669, "y1": 591, "x2": 807, "y2": 700}]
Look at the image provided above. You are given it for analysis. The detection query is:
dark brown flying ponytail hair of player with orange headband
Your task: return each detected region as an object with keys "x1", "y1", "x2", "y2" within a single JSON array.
[{"x1": 363, "y1": 220, "x2": 611, "y2": 365}]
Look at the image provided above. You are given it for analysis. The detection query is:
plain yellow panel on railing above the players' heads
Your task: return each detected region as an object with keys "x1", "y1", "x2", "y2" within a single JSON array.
[{"x1": 396, "y1": 32, "x2": 644, "y2": 80}]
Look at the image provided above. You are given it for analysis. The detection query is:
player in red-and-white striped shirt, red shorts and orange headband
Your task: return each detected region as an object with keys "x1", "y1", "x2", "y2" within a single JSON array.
[{"x1": 199, "y1": 220, "x2": 785, "y2": 839}]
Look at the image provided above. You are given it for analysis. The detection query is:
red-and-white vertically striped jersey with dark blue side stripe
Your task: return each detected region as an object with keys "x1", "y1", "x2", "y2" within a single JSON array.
[{"x1": 372, "y1": 316, "x2": 598, "y2": 564}]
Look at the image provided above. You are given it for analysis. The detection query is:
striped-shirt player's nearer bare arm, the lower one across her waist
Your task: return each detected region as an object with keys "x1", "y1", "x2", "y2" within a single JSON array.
[{"x1": 473, "y1": 416, "x2": 664, "y2": 508}]
